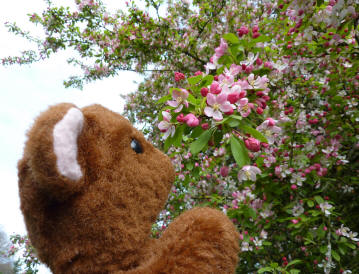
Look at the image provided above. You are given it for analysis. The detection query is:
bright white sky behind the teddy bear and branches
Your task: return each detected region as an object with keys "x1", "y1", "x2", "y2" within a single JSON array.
[{"x1": 0, "y1": 0, "x2": 142, "y2": 273}]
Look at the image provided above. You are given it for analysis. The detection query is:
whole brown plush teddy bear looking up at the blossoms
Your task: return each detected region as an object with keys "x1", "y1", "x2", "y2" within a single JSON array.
[{"x1": 18, "y1": 104, "x2": 239, "y2": 274}]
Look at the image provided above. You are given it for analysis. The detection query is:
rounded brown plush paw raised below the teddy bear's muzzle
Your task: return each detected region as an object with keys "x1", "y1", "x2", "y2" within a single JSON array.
[{"x1": 131, "y1": 208, "x2": 239, "y2": 274}]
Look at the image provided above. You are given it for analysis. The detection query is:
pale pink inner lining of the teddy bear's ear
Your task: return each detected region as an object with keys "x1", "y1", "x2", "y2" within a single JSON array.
[{"x1": 53, "y1": 108, "x2": 84, "y2": 181}]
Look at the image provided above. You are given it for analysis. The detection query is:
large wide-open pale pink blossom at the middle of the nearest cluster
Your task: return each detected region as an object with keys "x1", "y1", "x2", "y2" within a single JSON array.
[{"x1": 204, "y1": 93, "x2": 233, "y2": 121}]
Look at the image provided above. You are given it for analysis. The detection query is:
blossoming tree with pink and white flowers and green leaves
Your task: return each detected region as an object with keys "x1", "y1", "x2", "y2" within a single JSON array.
[{"x1": 2, "y1": 0, "x2": 359, "y2": 273}]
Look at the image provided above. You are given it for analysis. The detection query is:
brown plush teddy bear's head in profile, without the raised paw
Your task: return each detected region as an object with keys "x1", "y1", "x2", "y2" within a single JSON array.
[{"x1": 19, "y1": 104, "x2": 174, "y2": 273}]
